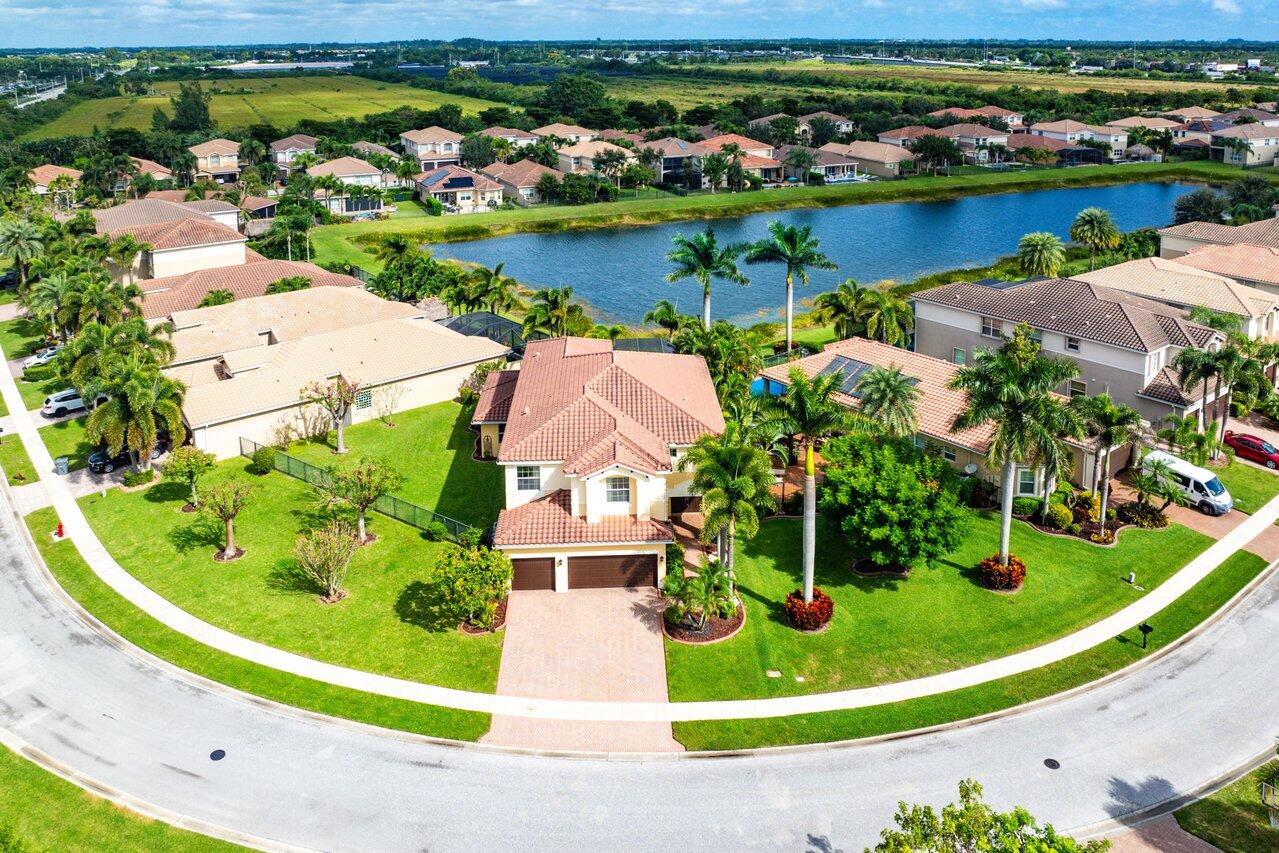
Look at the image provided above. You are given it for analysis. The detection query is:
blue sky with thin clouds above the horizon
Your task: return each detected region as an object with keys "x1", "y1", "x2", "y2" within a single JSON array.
[{"x1": 0, "y1": 0, "x2": 1279, "y2": 47}]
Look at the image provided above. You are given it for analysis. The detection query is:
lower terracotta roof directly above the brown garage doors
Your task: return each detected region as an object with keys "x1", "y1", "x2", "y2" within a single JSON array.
[{"x1": 494, "y1": 489, "x2": 675, "y2": 547}]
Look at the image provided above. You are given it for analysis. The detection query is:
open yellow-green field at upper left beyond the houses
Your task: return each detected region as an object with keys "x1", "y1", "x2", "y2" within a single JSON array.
[{"x1": 23, "y1": 75, "x2": 501, "y2": 139}]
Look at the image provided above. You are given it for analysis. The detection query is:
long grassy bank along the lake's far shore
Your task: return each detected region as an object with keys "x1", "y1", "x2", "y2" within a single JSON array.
[{"x1": 312, "y1": 161, "x2": 1242, "y2": 270}]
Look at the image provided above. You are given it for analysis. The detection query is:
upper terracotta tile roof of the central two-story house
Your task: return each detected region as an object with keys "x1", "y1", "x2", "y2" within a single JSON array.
[{"x1": 498, "y1": 338, "x2": 724, "y2": 474}]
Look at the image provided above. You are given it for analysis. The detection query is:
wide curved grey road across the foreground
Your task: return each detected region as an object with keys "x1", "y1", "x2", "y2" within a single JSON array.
[{"x1": 0, "y1": 496, "x2": 1279, "y2": 850}]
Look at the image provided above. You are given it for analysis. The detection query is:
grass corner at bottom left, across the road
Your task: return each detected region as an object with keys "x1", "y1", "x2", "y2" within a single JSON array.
[{"x1": 0, "y1": 747, "x2": 232, "y2": 853}]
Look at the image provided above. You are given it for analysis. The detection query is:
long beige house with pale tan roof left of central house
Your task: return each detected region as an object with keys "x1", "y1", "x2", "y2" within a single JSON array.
[{"x1": 165, "y1": 286, "x2": 509, "y2": 459}]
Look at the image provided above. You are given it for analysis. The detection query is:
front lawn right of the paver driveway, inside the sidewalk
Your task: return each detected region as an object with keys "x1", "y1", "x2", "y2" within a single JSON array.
[{"x1": 666, "y1": 514, "x2": 1211, "y2": 701}]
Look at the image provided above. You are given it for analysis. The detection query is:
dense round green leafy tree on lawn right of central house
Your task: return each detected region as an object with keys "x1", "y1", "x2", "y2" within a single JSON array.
[{"x1": 821, "y1": 435, "x2": 971, "y2": 569}]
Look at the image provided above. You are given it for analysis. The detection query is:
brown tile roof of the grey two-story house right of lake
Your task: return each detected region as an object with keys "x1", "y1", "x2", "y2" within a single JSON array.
[{"x1": 914, "y1": 279, "x2": 1220, "y2": 353}]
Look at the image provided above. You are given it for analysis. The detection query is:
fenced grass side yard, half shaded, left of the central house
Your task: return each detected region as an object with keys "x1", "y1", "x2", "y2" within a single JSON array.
[{"x1": 289, "y1": 402, "x2": 505, "y2": 527}]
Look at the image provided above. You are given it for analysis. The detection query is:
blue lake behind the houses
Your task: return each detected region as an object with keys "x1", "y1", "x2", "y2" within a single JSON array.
[{"x1": 431, "y1": 181, "x2": 1195, "y2": 324}]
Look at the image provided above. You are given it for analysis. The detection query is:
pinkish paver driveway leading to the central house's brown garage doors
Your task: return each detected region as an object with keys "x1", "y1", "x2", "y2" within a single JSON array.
[{"x1": 481, "y1": 588, "x2": 683, "y2": 752}]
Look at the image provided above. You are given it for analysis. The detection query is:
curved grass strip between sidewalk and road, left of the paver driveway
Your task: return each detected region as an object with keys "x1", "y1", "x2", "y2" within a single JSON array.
[{"x1": 31, "y1": 506, "x2": 489, "y2": 741}]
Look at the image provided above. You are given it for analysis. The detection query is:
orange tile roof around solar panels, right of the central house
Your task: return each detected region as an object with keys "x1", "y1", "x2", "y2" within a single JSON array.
[{"x1": 762, "y1": 338, "x2": 995, "y2": 453}]
